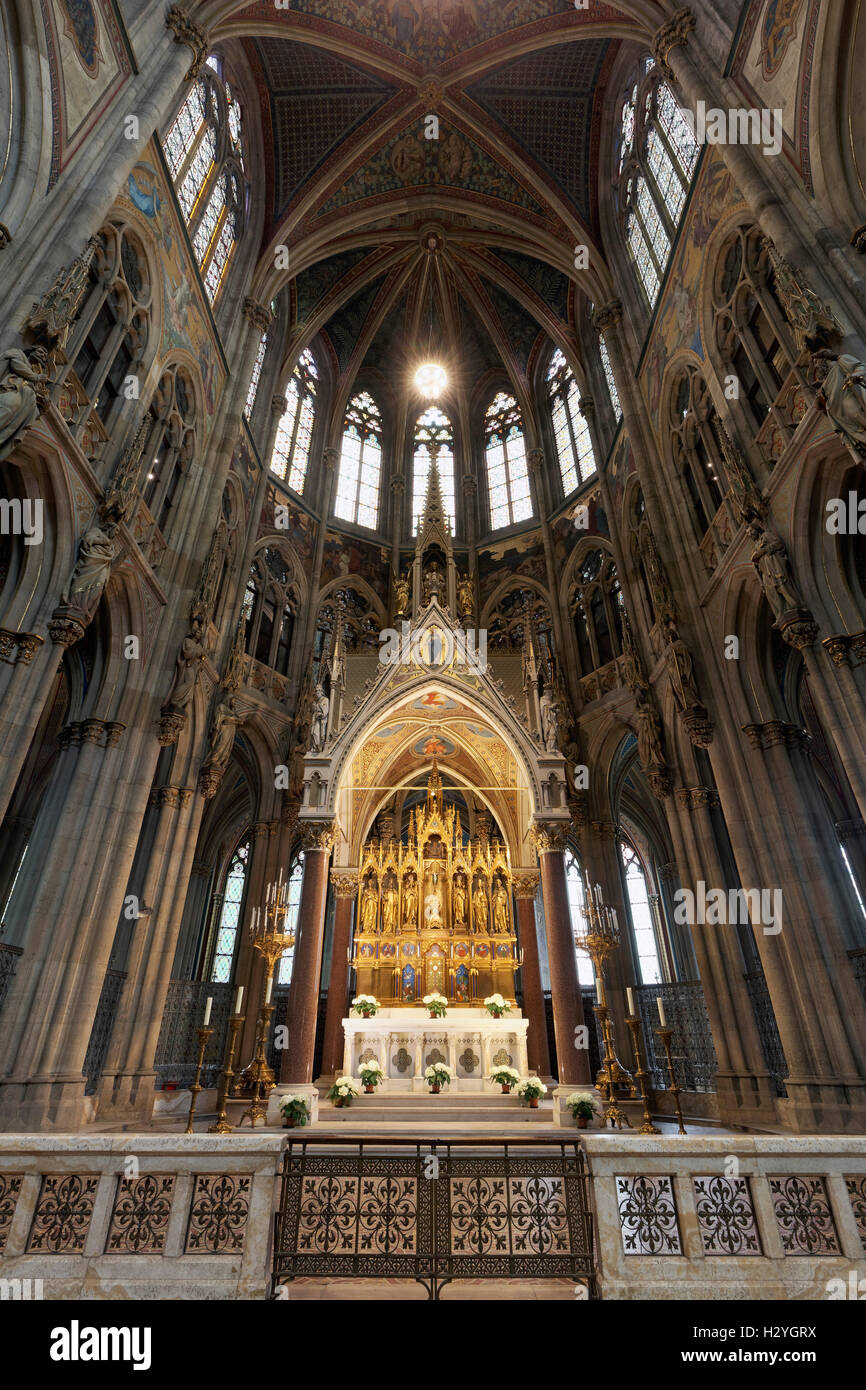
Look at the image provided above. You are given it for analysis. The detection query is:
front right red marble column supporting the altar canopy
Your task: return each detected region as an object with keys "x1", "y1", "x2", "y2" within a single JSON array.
[{"x1": 532, "y1": 824, "x2": 592, "y2": 1086}]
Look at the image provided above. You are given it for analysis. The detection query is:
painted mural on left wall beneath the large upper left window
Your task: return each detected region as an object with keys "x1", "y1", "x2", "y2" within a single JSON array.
[{"x1": 118, "y1": 155, "x2": 224, "y2": 428}]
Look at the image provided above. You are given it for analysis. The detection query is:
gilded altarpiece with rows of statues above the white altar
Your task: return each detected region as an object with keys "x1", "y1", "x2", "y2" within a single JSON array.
[{"x1": 353, "y1": 759, "x2": 520, "y2": 1006}]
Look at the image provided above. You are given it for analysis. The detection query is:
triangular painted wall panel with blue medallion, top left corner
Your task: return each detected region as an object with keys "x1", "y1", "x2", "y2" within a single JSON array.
[{"x1": 40, "y1": 0, "x2": 132, "y2": 188}]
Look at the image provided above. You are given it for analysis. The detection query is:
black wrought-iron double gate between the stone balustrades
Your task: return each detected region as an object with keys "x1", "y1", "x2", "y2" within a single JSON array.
[{"x1": 274, "y1": 1137, "x2": 596, "y2": 1300}]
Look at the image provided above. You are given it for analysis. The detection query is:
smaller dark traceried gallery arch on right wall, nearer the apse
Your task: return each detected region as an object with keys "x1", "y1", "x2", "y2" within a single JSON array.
[{"x1": 670, "y1": 367, "x2": 727, "y2": 537}]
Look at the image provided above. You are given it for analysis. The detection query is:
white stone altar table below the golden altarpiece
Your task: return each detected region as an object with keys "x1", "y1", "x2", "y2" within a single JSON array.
[{"x1": 343, "y1": 1008, "x2": 530, "y2": 1091}]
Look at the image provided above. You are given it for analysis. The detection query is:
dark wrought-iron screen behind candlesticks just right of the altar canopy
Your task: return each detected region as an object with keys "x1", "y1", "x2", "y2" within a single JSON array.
[{"x1": 634, "y1": 980, "x2": 719, "y2": 1091}]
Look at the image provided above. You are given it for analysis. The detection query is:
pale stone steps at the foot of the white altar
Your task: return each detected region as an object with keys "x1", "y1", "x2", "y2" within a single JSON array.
[{"x1": 318, "y1": 1091, "x2": 552, "y2": 1127}]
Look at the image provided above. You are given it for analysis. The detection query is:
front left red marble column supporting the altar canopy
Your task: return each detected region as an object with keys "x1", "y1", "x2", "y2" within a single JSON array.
[{"x1": 279, "y1": 823, "x2": 334, "y2": 1086}]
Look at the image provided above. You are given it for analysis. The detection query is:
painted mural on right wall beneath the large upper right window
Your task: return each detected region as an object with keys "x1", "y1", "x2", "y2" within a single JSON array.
[{"x1": 641, "y1": 158, "x2": 742, "y2": 414}]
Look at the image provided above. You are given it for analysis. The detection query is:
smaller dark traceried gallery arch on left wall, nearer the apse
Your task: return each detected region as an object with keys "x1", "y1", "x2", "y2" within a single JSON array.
[{"x1": 142, "y1": 367, "x2": 196, "y2": 535}]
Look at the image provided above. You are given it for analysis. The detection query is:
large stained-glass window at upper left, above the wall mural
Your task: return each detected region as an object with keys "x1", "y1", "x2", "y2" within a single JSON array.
[{"x1": 163, "y1": 54, "x2": 247, "y2": 303}]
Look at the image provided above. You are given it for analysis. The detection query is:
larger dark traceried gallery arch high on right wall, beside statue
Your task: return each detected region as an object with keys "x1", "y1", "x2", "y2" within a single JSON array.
[{"x1": 713, "y1": 227, "x2": 796, "y2": 464}]
